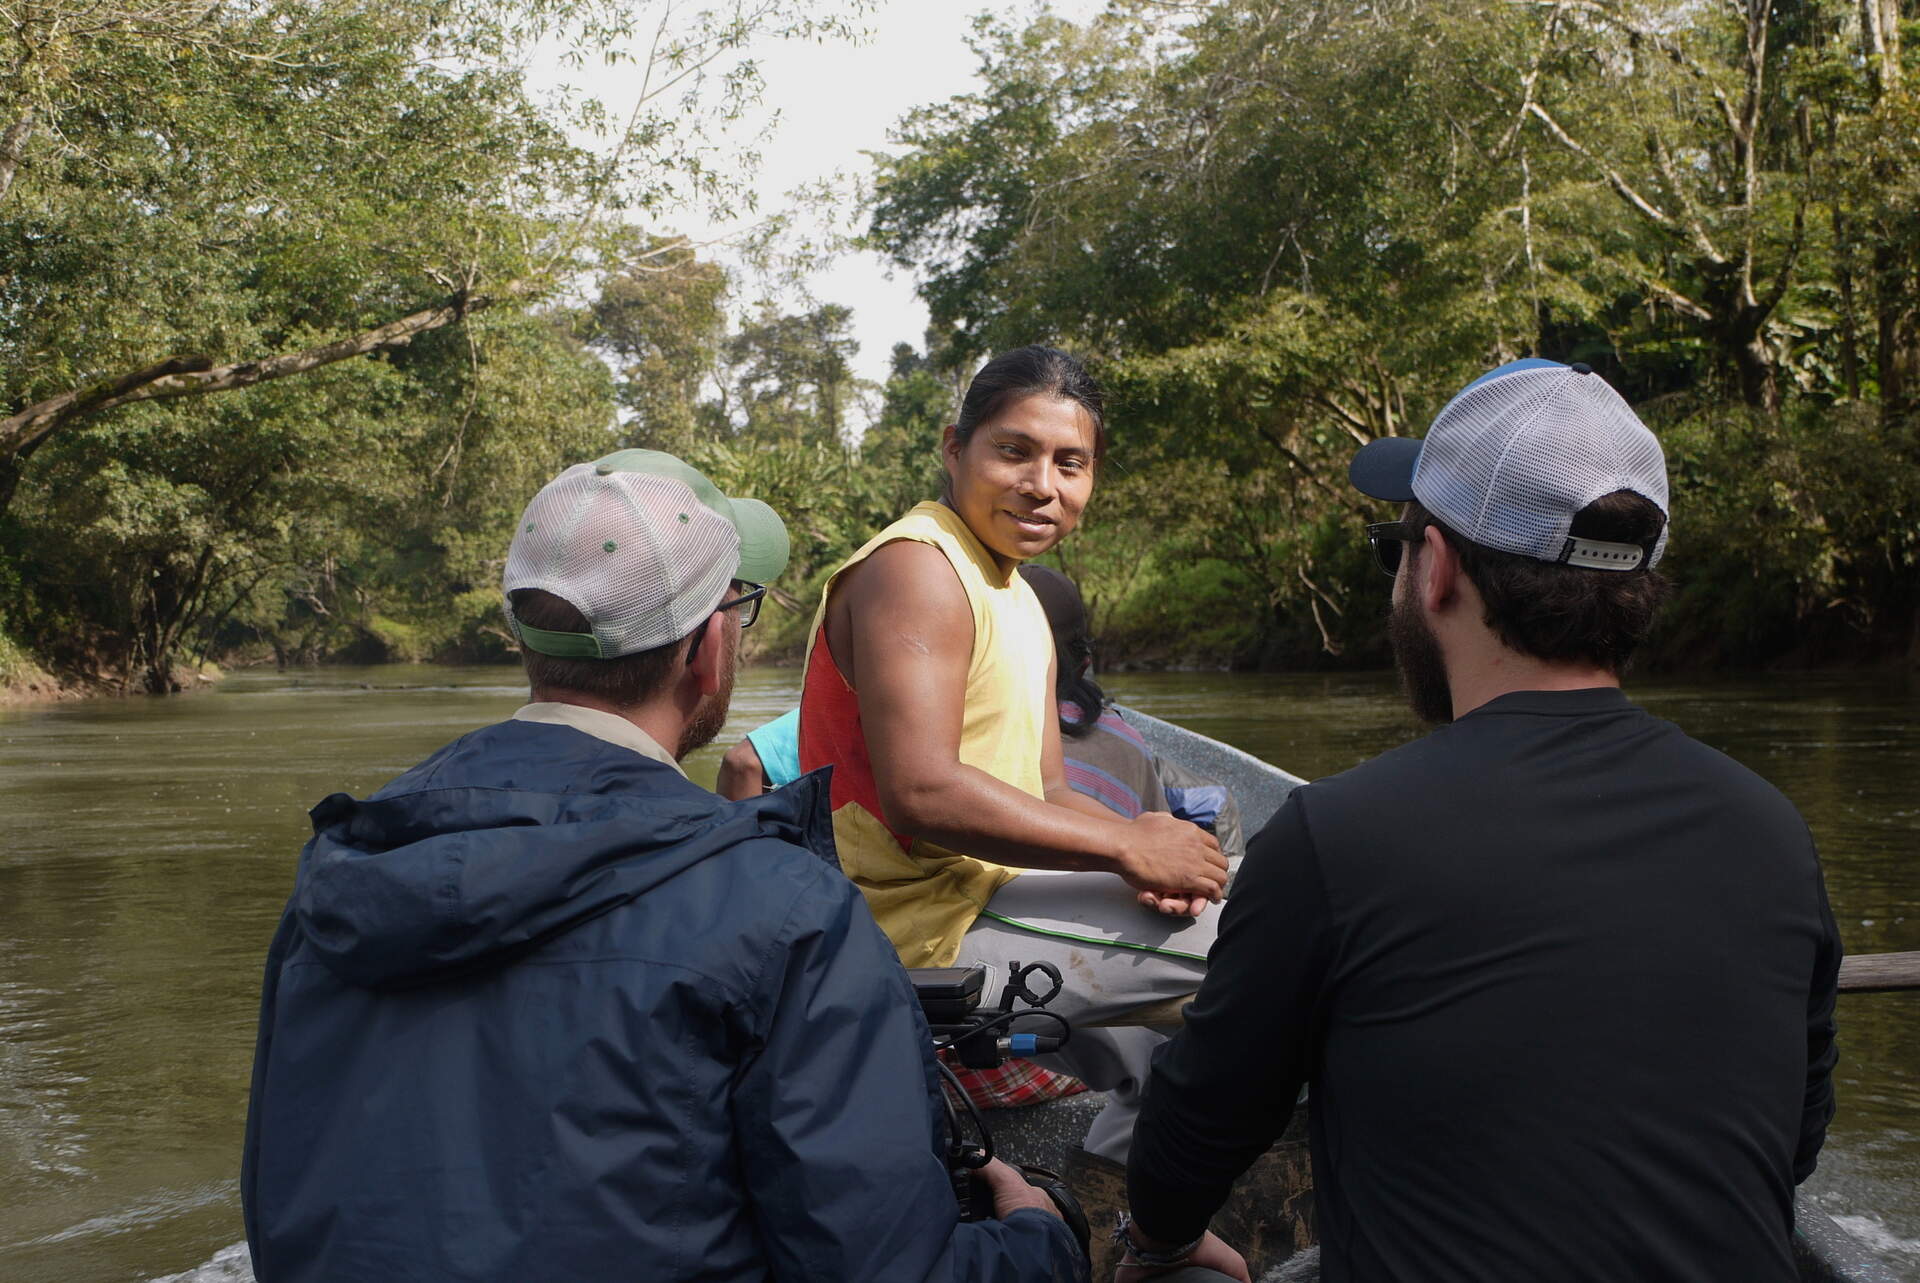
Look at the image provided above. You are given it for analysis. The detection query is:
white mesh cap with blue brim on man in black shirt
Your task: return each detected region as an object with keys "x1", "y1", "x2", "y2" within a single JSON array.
[{"x1": 1348, "y1": 357, "x2": 1667, "y2": 570}]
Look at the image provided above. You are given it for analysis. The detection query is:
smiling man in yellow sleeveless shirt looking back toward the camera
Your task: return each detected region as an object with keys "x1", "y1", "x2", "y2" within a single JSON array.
[{"x1": 801, "y1": 348, "x2": 1227, "y2": 1160}]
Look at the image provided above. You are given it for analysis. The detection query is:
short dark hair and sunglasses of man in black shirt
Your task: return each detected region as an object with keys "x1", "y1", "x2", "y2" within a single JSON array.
[{"x1": 1405, "y1": 490, "x2": 1667, "y2": 672}]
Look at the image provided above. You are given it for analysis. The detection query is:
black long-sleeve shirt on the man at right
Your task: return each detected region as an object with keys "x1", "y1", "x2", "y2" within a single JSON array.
[{"x1": 1129, "y1": 690, "x2": 1839, "y2": 1283}]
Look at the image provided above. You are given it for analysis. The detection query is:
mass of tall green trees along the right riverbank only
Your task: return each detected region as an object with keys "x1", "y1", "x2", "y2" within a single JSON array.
[{"x1": 870, "y1": 0, "x2": 1920, "y2": 663}]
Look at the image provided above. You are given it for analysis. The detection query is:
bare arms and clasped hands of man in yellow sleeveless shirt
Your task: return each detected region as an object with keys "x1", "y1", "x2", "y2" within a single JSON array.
[{"x1": 828, "y1": 540, "x2": 1227, "y2": 899}]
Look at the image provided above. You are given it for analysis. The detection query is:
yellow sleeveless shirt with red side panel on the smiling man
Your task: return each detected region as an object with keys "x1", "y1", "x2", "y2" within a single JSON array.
[{"x1": 801, "y1": 501, "x2": 1054, "y2": 966}]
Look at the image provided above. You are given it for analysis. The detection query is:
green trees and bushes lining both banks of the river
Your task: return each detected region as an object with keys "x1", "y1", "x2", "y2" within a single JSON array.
[{"x1": 0, "y1": 0, "x2": 1920, "y2": 691}]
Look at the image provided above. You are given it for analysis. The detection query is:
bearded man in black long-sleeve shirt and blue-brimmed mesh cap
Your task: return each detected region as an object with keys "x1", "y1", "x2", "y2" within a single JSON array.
[{"x1": 1129, "y1": 359, "x2": 1839, "y2": 1283}]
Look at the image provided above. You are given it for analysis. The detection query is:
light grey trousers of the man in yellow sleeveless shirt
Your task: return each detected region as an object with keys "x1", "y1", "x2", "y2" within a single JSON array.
[{"x1": 958, "y1": 874, "x2": 1219, "y2": 1162}]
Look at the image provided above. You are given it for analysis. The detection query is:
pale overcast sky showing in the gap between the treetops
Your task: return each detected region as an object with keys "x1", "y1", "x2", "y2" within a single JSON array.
[{"x1": 541, "y1": 0, "x2": 1104, "y2": 391}]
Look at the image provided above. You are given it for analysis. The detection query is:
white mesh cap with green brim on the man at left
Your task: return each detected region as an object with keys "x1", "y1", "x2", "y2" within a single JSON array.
[{"x1": 501, "y1": 449, "x2": 787, "y2": 659}]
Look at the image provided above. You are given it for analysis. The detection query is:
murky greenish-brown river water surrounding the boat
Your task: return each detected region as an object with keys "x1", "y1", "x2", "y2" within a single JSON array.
[{"x1": 0, "y1": 666, "x2": 1920, "y2": 1283}]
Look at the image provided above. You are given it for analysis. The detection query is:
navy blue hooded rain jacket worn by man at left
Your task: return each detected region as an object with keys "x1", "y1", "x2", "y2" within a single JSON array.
[{"x1": 242, "y1": 722, "x2": 1087, "y2": 1283}]
